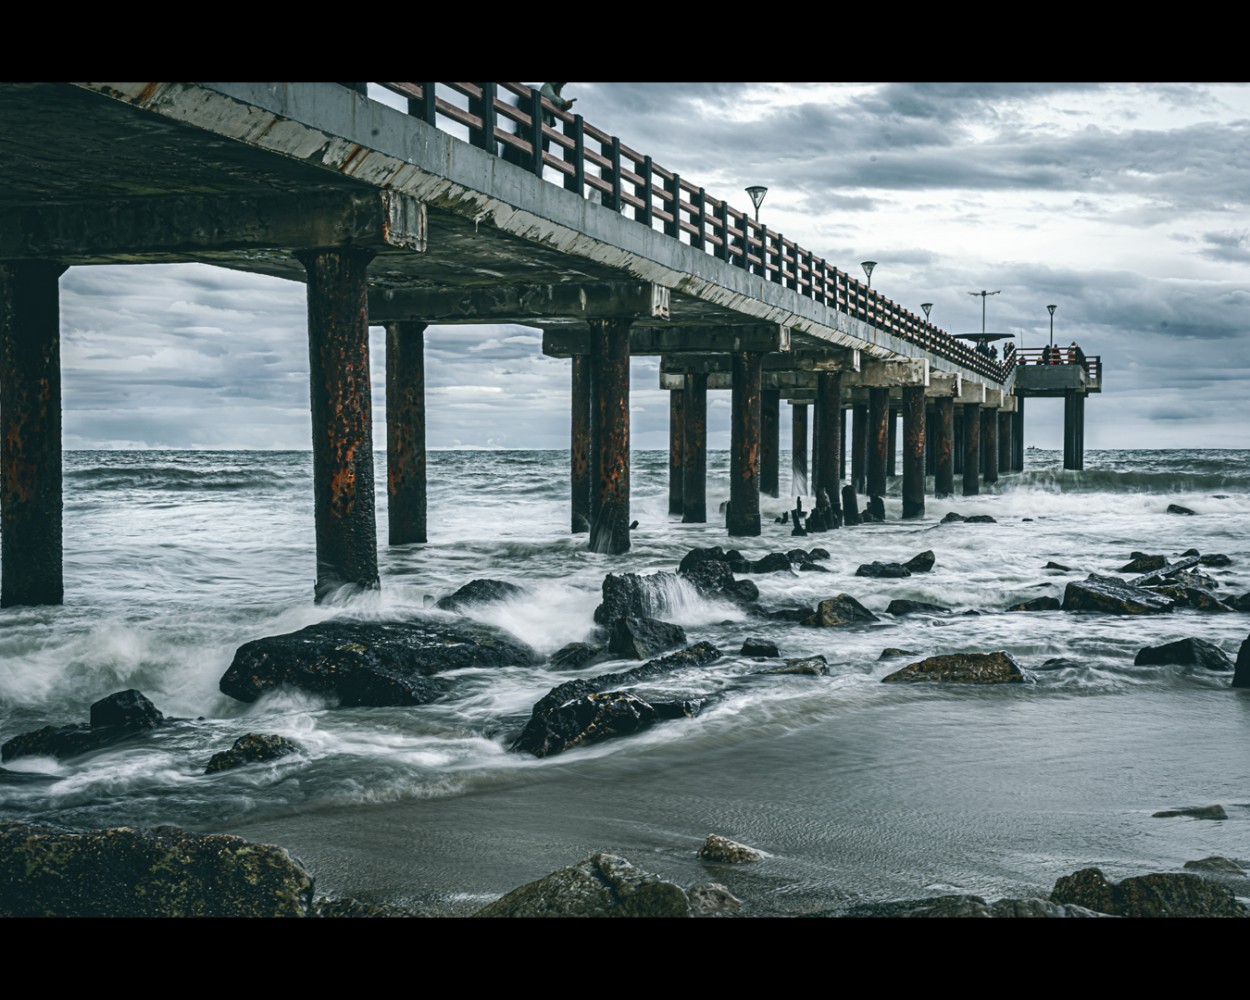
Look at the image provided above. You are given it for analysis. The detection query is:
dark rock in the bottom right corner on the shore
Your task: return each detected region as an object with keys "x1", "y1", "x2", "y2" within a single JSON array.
[{"x1": 1050, "y1": 868, "x2": 1246, "y2": 916}]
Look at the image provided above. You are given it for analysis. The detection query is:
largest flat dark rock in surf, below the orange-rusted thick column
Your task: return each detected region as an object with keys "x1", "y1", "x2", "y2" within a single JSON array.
[{"x1": 219, "y1": 619, "x2": 536, "y2": 705}]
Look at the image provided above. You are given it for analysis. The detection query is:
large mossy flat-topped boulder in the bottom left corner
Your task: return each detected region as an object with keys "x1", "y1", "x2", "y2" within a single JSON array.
[{"x1": 0, "y1": 823, "x2": 313, "y2": 918}]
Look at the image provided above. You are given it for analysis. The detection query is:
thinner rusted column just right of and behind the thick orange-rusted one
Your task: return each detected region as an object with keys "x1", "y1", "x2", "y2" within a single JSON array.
[{"x1": 386, "y1": 321, "x2": 426, "y2": 545}]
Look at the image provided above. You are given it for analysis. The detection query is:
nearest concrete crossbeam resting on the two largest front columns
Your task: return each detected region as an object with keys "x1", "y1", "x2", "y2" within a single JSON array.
[{"x1": 0, "y1": 190, "x2": 426, "y2": 261}]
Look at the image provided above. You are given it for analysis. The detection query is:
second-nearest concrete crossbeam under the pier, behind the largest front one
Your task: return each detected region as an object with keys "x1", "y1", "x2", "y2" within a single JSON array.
[{"x1": 369, "y1": 281, "x2": 670, "y2": 325}]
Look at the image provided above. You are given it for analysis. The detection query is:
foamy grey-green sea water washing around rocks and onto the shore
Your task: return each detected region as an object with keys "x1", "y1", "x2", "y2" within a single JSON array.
[{"x1": 0, "y1": 450, "x2": 1250, "y2": 915}]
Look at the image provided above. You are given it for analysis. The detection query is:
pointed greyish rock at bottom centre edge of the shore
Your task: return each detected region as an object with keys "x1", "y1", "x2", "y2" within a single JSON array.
[{"x1": 475, "y1": 854, "x2": 690, "y2": 918}]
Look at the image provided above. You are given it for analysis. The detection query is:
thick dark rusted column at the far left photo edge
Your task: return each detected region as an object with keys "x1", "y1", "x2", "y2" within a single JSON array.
[{"x1": 0, "y1": 261, "x2": 65, "y2": 608}]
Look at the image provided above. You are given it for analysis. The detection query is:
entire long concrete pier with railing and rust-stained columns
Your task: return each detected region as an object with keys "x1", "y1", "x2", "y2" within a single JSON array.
[{"x1": 0, "y1": 83, "x2": 1101, "y2": 606}]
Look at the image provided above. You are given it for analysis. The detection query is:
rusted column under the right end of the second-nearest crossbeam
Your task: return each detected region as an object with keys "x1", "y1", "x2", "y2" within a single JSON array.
[{"x1": 590, "y1": 319, "x2": 633, "y2": 555}]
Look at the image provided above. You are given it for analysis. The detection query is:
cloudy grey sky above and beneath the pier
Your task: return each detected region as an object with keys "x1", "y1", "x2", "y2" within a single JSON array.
[{"x1": 61, "y1": 83, "x2": 1250, "y2": 449}]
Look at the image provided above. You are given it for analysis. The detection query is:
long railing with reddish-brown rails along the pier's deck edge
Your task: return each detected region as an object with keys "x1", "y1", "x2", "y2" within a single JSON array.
[{"x1": 372, "y1": 83, "x2": 1010, "y2": 383}]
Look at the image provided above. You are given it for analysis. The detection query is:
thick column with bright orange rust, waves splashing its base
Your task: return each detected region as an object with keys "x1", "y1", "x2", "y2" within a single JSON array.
[{"x1": 295, "y1": 250, "x2": 379, "y2": 603}]
